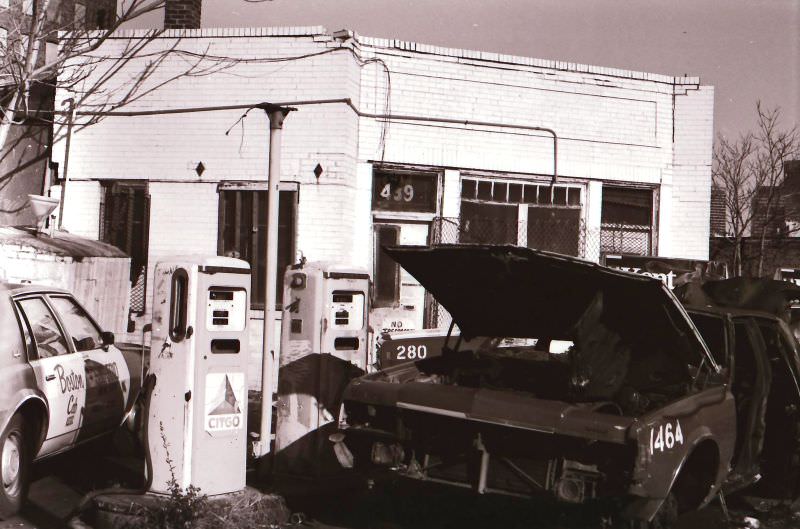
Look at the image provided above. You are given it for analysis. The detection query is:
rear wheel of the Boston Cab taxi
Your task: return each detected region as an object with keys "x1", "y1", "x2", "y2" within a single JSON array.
[{"x1": 0, "y1": 414, "x2": 31, "y2": 519}]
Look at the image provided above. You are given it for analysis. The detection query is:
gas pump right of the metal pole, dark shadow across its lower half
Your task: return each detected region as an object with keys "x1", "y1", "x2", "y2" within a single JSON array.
[{"x1": 275, "y1": 262, "x2": 370, "y2": 476}]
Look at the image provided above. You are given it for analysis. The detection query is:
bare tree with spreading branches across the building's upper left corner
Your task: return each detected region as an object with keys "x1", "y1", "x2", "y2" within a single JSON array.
[{"x1": 0, "y1": 0, "x2": 235, "y2": 185}]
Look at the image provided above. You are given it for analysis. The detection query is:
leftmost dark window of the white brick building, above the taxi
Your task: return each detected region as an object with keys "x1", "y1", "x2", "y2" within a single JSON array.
[{"x1": 100, "y1": 182, "x2": 150, "y2": 314}]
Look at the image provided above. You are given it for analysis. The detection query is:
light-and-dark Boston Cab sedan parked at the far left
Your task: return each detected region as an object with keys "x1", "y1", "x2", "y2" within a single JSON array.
[{"x1": 0, "y1": 282, "x2": 142, "y2": 518}]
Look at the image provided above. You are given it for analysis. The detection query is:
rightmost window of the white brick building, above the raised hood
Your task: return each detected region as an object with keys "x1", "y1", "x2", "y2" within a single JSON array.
[{"x1": 600, "y1": 186, "x2": 653, "y2": 255}]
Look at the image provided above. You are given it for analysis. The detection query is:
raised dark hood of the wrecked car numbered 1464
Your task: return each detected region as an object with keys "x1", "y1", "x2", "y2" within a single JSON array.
[{"x1": 384, "y1": 245, "x2": 717, "y2": 367}]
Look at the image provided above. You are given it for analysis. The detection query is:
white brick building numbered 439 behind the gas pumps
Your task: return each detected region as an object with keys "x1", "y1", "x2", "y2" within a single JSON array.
[{"x1": 55, "y1": 27, "x2": 713, "y2": 380}]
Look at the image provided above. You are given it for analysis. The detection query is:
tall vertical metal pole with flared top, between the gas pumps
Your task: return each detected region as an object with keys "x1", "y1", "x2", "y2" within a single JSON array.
[{"x1": 253, "y1": 103, "x2": 295, "y2": 457}]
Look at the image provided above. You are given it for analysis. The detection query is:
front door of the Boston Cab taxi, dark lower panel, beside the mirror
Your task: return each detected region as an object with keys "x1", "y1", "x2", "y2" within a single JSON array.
[{"x1": 48, "y1": 294, "x2": 130, "y2": 442}]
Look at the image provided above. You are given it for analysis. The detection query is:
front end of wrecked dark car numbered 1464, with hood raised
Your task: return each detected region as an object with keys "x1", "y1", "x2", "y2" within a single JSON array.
[{"x1": 340, "y1": 246, "x2": 736, "y2": 526}]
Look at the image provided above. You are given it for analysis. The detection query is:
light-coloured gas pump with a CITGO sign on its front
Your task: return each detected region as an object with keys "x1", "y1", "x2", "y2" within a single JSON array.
[{"x1": 146, "y1": 256, "x2": 250, "y2": 496}]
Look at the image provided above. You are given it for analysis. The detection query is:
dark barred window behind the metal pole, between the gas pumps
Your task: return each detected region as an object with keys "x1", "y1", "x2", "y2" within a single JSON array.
[{"x1": 217, "y1": 189, "x2": 297, "y2": 309}]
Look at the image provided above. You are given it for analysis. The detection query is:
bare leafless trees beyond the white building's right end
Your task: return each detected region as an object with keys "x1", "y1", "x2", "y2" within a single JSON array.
[{"x1": 712, "y1": 101, "x2": 800, "y2": 276}]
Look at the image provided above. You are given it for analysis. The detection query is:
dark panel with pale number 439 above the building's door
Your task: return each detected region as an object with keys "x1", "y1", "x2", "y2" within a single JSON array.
[{"x1": 372, "y1": 172, "x2": 438, "y2": 212}]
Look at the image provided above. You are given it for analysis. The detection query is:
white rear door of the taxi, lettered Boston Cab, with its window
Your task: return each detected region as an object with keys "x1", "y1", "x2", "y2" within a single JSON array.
[{"x1": 14, "y1": 295, "x2": 86, "y2": 455}]
